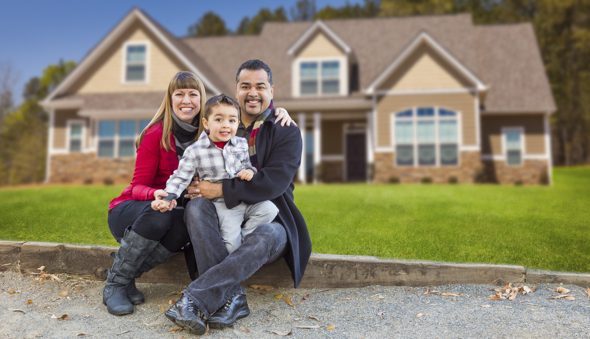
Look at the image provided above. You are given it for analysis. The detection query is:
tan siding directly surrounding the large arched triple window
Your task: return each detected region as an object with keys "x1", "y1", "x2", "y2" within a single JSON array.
[{"x1": 375, "y1": 93, "x2": 477, "y2": 147}]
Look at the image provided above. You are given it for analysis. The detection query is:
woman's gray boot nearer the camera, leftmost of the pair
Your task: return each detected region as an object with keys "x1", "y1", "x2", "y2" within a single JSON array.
[{"x1": 102, "y1": 230, "x2": 159, "y2": 315}]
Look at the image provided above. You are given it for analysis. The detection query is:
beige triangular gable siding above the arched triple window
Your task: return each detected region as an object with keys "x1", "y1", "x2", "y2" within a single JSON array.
[{"x1": 381, "y1": 46, "x2": 473, "y2": 91}]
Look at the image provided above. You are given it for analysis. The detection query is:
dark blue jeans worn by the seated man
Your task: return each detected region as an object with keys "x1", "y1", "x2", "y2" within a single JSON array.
[{"x1": 184, "y1": 198, "x2": 287, "y2": 316}]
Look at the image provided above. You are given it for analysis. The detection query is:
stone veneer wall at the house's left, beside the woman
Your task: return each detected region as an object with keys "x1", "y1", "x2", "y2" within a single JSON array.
[{"x1": 49, "y1": 153, "x2": 135, "y2": 183}]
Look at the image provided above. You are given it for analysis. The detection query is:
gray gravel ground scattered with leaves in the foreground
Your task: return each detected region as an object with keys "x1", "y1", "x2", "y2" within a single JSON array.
[{"x1": 0, "y1": 271, "x2": 590, "y2": 338}]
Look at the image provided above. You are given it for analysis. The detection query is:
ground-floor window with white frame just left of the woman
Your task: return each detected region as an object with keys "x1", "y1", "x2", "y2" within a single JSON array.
[{"x1": 98, "y1": 120, "x2": 150, "y2": 158}]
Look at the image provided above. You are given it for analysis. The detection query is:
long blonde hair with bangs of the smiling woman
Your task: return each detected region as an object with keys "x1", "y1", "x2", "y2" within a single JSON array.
[{"x1": 135, "y1": 71, "x2": 207, "y2": 151}]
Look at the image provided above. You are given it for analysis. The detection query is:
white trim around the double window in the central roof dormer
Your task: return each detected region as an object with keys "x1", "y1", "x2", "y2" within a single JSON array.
[{"x1": 291, "y1": 56, "x2": 349, "y2": 98}]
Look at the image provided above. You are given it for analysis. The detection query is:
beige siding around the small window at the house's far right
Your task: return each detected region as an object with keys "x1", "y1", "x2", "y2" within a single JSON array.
[{"x1": 481, "y1": 114, "x2": 545, "y2": 155}]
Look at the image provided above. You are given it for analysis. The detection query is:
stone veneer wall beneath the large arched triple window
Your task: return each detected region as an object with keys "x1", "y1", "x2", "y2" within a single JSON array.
[{"x1": 373, "y1": 152, "x2": 483, "y2": 183}]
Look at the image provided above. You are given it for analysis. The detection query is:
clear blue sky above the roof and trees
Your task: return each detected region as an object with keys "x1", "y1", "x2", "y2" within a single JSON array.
[{"x1": 0, "y1": 0, "x2": 363, "y2": 103}]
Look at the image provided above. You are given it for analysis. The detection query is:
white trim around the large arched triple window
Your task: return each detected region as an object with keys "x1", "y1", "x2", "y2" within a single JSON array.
[{"x1": 390, "y1": 105, "x2": 463, "y2": 168}]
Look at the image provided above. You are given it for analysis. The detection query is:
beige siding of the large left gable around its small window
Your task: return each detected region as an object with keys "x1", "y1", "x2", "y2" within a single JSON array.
[{"x1": 74, "y1": 25, "x2": 180, "y2": 93}]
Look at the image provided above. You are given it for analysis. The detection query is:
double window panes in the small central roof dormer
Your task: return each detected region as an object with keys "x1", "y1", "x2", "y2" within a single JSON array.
[{"x1": 299, "y1": 60, "x2": 340, "y2": 95}]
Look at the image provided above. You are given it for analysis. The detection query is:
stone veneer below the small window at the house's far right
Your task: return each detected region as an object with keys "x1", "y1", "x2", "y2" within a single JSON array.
[{"x1": 483, "y1": 160, "x2": 549, "y2": 185}]
